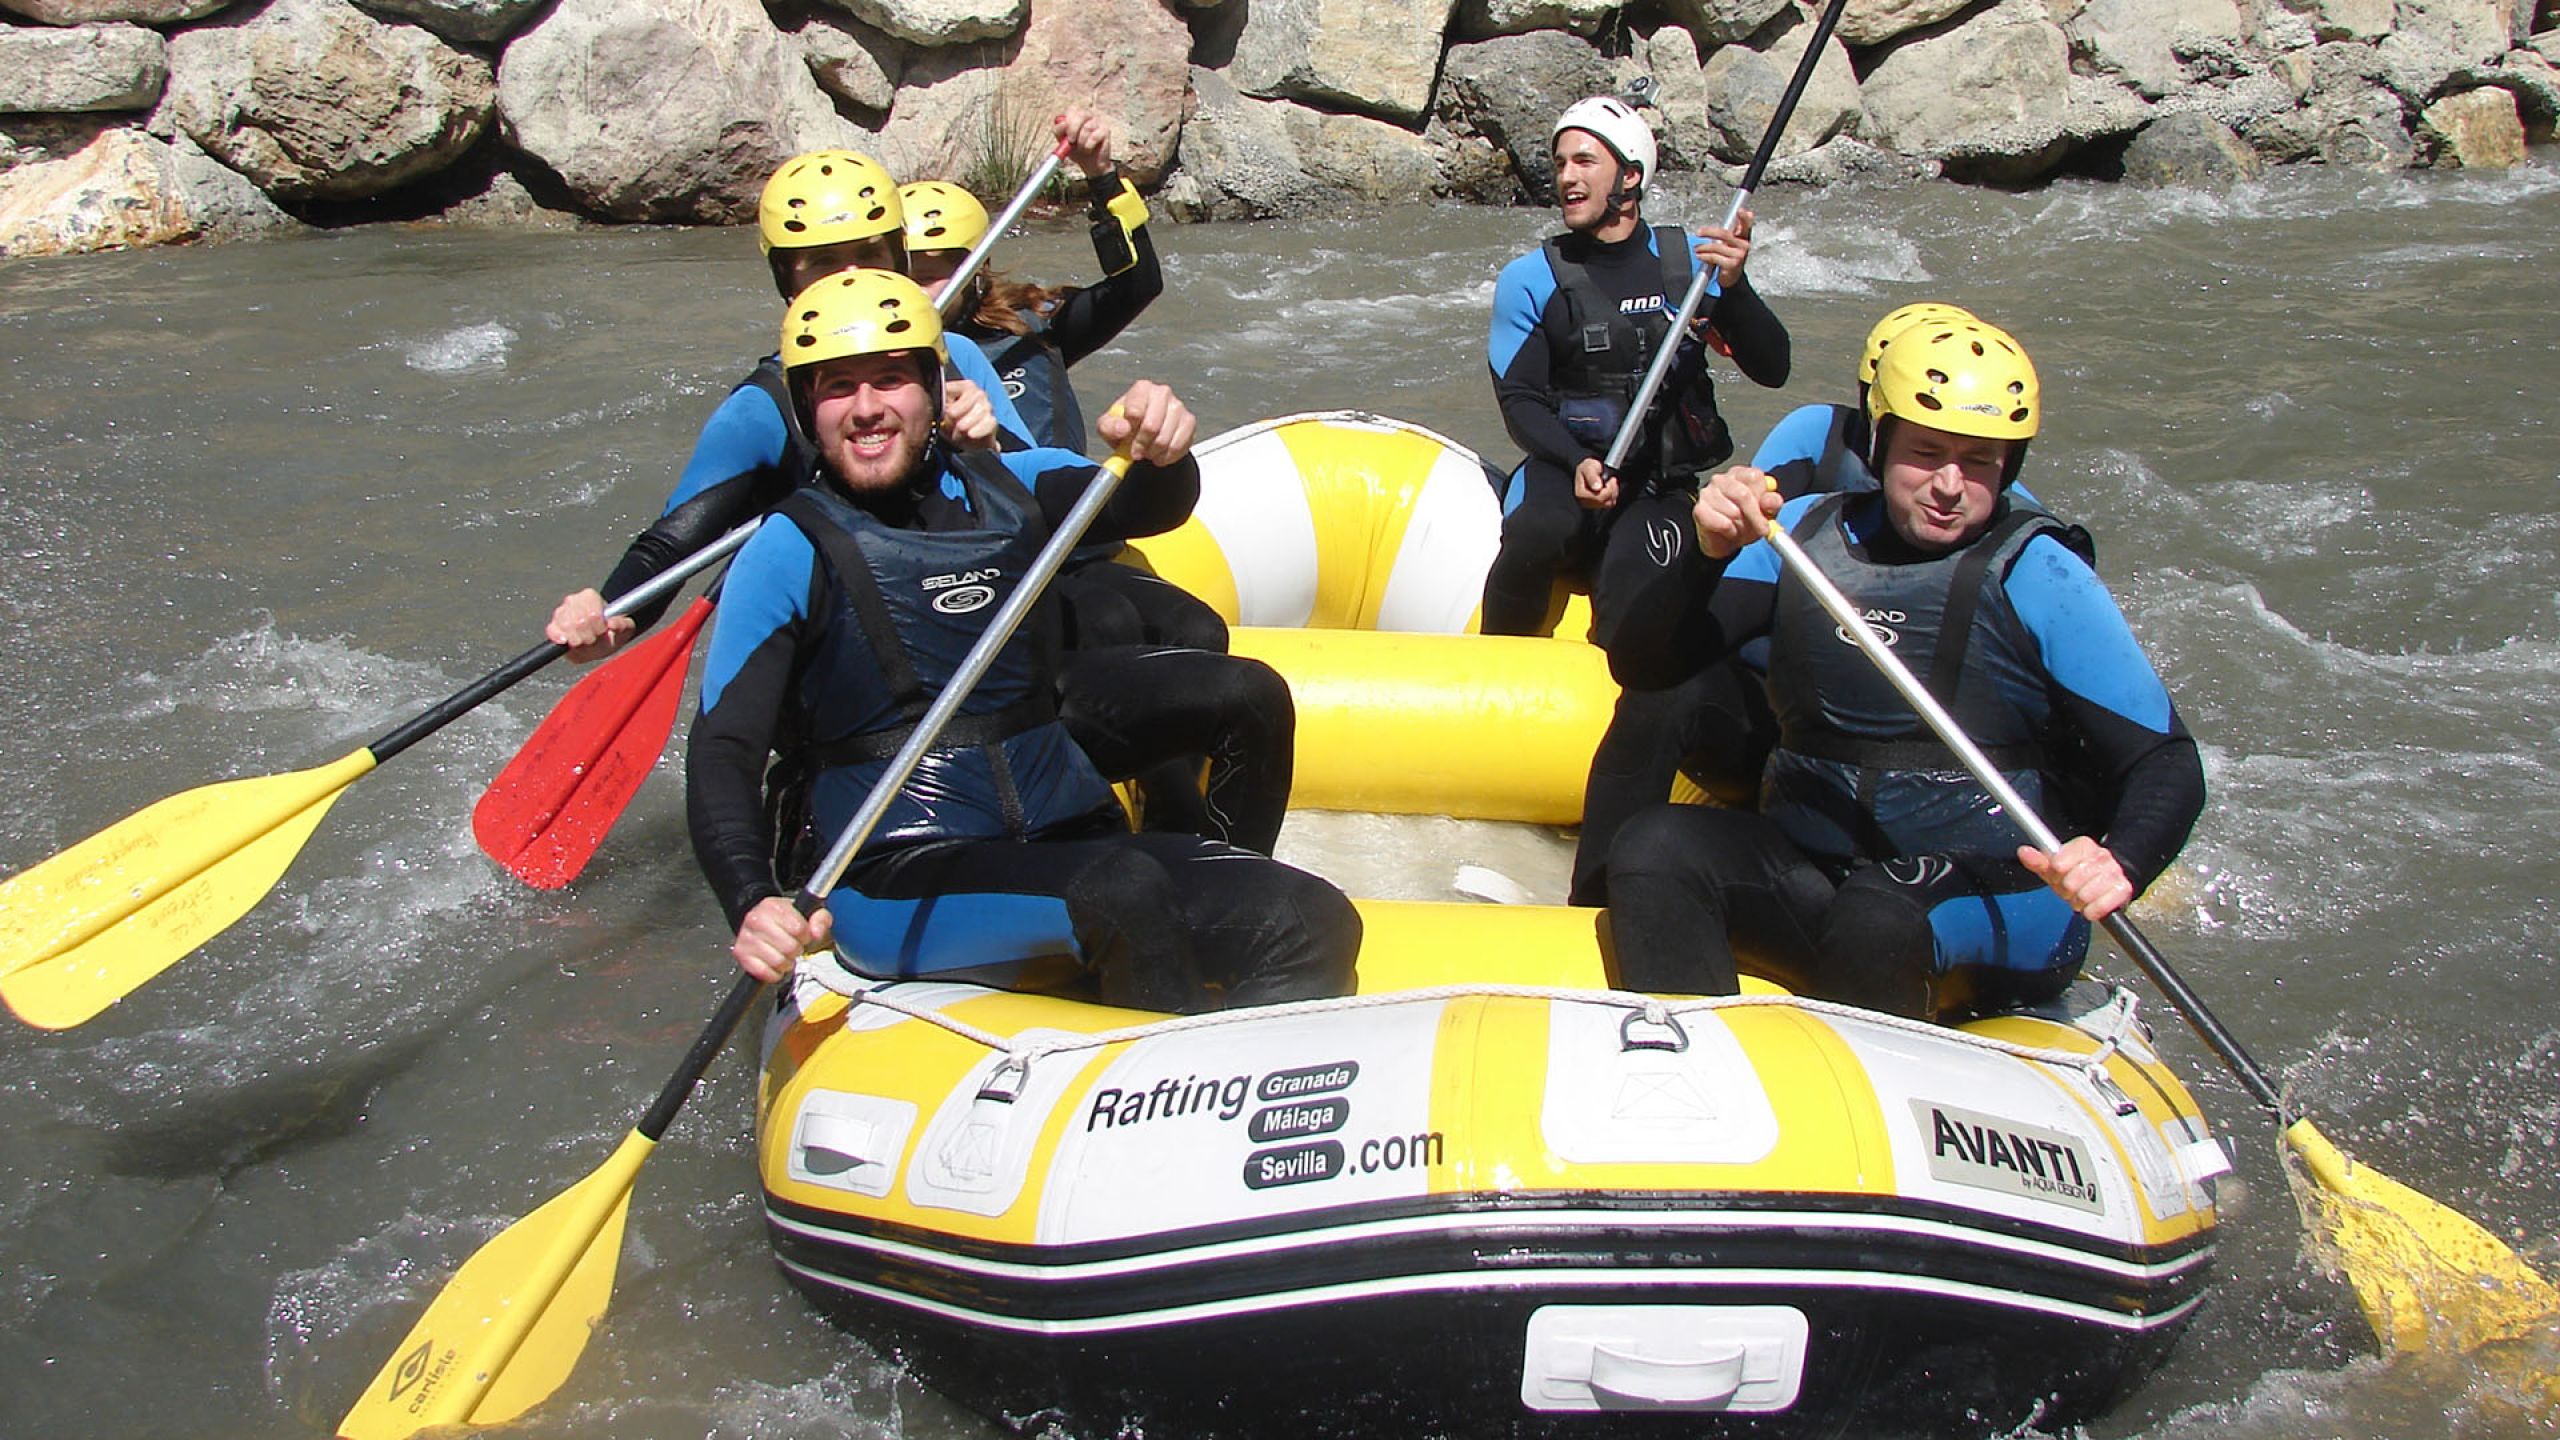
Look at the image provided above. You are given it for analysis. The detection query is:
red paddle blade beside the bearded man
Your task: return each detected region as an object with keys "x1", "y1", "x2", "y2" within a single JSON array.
[{"x1": 471, "y1": 597, "x2": 712, "y2": 889}]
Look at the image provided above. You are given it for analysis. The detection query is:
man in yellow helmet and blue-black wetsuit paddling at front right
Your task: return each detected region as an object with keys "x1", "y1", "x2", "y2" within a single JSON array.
[{"x1": 1608, "y1": 320, "x2": 2204, "y2": 1017}]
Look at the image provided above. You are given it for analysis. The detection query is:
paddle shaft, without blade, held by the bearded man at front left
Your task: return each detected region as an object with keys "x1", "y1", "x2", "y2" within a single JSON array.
[{"x1": 640, "y1": 456, "x2": 1129, "y2": 1140}]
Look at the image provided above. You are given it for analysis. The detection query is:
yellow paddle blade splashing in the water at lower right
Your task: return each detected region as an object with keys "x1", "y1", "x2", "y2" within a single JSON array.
[{"x1": 2284, "y1": 1120, "x2": 2560, "y2": 1350}]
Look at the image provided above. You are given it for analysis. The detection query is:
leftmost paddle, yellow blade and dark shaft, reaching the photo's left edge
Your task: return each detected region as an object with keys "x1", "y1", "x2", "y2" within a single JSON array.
[{"x1": 0, "y1": 525, "x2": 750, "y2": 1030}]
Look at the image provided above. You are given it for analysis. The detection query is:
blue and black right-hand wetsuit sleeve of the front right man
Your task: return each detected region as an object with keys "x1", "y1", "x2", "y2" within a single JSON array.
[{"x1": 2004, "y1": 536, "x2": 2204, "y2": 892}]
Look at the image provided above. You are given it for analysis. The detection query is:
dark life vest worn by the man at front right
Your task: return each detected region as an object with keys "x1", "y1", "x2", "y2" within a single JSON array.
[{"x1": 1761, "y1": 495, "x2": 2086, "y2": 861}]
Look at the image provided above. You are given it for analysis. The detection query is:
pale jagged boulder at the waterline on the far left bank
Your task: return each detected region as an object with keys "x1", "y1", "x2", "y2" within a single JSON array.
[{"x1": 0, "y1": 128, "x2": 294, "y2": 256}]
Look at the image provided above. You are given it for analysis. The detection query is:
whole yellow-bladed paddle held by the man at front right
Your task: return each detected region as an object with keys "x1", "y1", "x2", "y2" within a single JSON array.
[{"x1": 1769, "y1": 515, "x2": 2560, "y2": 1350}]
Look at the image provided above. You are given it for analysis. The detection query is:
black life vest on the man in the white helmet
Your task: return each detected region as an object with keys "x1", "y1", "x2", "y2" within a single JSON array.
[{"x1": 1539, "y1": 225, "x2": 1733, "y2": 477}]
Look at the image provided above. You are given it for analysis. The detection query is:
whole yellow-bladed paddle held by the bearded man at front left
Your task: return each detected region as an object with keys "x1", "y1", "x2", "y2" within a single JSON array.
[{"x1": 338, "y1": 454, "x2": 1129, "y2": 1440}]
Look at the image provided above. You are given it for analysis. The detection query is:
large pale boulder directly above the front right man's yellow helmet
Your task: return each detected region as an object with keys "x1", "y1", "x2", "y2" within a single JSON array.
[{"x1": 1861, "y1": 0, "x2": 2071, "y2": 182}]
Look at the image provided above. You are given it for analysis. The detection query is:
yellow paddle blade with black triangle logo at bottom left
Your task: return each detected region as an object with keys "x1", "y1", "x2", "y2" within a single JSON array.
[{"x1": 338, "y1": 1130, "x2": 658, "y2": 1440}]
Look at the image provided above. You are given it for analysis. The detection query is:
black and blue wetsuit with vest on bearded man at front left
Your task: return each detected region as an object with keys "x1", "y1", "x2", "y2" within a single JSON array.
[{"x1": 686, "y1": 446, "x2": 1359, "y2": 1010}]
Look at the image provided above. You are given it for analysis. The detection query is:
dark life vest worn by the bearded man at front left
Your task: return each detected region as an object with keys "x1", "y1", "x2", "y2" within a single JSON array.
[{"x1": 776, "y1": 451, "x2": 1111, "y2": 851}]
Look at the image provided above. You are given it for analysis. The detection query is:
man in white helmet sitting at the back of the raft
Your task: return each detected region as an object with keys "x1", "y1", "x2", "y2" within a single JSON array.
[{"x1": 1482, "y1": 95, "x2": 1789, "y2": 904}]
